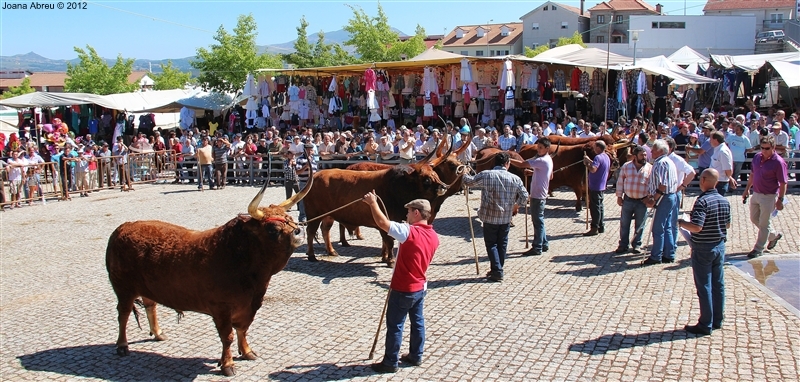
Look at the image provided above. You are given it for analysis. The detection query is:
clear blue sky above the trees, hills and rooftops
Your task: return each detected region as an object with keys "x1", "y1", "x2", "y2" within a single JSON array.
[{"x1": 0, "y1": 0, "x2": 706, "y2": 59}]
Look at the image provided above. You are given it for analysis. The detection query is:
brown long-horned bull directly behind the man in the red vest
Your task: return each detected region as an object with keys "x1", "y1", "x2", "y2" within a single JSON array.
[{"x1": 303, "y1": 137, "x2": 460, "y2": 266}]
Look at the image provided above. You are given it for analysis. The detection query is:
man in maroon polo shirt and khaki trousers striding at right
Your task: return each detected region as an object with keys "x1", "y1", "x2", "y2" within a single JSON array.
[{"x1": 742, "y1": 135, "x2": 788, "y2": 259}]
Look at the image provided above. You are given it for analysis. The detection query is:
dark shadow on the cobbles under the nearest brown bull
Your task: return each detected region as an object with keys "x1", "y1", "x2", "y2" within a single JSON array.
[{"x1": 17, "y1": 343, "x2": 217, "y2": 381}]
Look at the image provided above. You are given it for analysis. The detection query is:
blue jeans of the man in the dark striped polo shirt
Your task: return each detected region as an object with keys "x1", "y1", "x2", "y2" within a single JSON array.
[{"x1": 691, "y1": 240, "x2": 725, "y2": 330}]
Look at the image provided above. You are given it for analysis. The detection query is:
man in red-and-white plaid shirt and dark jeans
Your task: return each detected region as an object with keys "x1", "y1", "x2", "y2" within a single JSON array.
[{"x1": 614, "y1": 146, "x2": 653, "y2": 254}]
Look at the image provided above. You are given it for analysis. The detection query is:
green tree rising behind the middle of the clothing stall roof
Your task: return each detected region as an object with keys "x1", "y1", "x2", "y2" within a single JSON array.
[{"x1": 344, "y1": 2, "x2": 425, "y2": 62}]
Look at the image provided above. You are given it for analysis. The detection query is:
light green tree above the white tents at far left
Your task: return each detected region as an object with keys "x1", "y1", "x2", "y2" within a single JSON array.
[{"x1": 64, "y1": 45, "x2": 139, "y2": 95}]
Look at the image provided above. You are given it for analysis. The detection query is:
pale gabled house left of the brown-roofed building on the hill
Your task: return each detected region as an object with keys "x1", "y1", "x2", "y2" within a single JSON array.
[{"x1": 519, "y1": 1, "x2": 589, "y2": 49}]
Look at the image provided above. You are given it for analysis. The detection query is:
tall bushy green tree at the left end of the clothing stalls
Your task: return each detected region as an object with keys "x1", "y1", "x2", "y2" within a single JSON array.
[{"x1": 191, "y1": 14, "x2": 283, "y2": 93}]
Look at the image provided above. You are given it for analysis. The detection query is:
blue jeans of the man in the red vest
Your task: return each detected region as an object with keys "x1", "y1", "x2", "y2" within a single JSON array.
[{"x1": 382, "y1": 290, "x2": 428, "y2": 367}]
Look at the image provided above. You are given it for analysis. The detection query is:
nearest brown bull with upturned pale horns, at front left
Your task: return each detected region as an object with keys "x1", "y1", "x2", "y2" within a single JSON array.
[{"x1": 106, "y1": 182, "x2": 312, "y2": 376}]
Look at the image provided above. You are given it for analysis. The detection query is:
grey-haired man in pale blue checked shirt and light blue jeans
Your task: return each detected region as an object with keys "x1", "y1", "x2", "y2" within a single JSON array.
[{"x1": 642, "y1": 139, "x2": 679, "y2": 266}]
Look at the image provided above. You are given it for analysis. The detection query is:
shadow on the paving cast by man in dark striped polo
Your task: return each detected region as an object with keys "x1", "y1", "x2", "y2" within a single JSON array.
[{"x1": 569, "y1": 330, "x2": 695, "y2": 355}]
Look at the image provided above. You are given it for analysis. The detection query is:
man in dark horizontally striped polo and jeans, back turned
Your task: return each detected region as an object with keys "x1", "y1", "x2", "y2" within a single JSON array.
[{"x1": 678, "y1": 168, "x2": 731, "y2": 335}]
